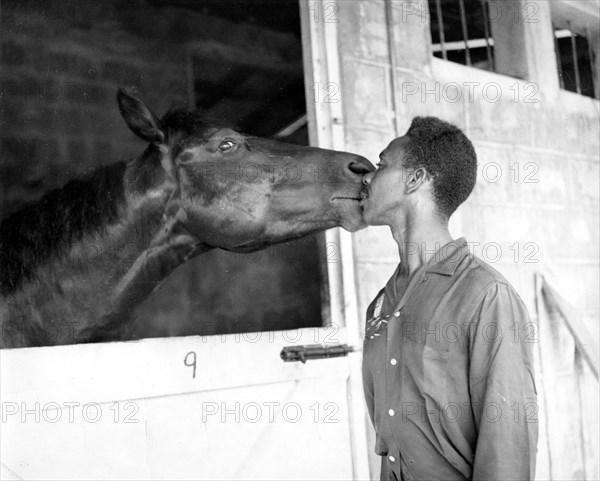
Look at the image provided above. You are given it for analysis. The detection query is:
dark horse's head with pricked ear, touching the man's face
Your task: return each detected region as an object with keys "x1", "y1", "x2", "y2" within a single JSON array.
[{"x1": 118, "y1": 90, "x2": 373, "y2": 251}]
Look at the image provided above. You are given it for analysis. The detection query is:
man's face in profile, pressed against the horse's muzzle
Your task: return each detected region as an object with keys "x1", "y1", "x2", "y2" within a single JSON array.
[{"x1": 360, "y1": 137, "x2": 409, "y2": 225}]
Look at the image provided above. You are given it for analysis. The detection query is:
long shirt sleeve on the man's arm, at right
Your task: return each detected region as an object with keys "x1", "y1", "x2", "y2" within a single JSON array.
[{"x1": 469, "y1": 283, "x2": 538, "y2": 481}]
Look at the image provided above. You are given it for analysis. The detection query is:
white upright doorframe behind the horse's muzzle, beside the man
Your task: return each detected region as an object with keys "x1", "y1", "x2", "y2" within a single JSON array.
[{"x1": 299, "y1": 0, "x2": 370, "y2": 479}]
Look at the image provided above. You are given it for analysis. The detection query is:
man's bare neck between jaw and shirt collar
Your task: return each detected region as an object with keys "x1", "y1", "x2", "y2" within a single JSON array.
[{"x1": 390, "y1": 212, "x2": 452, "y2": 277}]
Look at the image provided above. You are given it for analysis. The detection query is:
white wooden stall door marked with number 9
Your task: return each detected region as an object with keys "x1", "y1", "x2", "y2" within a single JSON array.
[{"x1": 0, "y1": 329, "x2": 366, "y2": 479}]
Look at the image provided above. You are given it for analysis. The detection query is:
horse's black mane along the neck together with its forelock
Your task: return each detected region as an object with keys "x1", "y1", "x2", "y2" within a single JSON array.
[{"x1": 0, "y1": 108, "x2": 235, "y2": 294}]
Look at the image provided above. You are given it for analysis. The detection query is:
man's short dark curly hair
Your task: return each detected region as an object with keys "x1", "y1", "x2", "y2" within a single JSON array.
[{"x1": 404, "y1": 117, "x2": 477, "y2": 218}]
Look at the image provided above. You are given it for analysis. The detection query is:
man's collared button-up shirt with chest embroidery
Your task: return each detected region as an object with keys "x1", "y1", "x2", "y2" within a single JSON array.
[{"x1": 363, "y1": 238, "x2": 538, "y2": 480}]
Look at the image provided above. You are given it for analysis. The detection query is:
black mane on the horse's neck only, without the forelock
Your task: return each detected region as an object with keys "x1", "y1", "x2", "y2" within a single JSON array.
[{"x1": 0, "y1": 162, "x2": 126, "y2": 294}]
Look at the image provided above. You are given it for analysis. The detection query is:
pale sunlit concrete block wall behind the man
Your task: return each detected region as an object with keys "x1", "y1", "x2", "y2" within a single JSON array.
[{"x1": 338, "y1": 1, "x2": 600, "y2": 479}]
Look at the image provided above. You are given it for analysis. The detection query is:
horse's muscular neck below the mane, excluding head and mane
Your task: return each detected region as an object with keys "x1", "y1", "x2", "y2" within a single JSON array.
[{"x1": 2, "y1": 161, "x2": 202, "y2": 345}]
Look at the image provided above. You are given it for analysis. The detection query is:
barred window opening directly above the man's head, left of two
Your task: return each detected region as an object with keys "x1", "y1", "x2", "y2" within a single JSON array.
[{"x1": 429, "y1": 0, "x2": 495, "y2": 71}]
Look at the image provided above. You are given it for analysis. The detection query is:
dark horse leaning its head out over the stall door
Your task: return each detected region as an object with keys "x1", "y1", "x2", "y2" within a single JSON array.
[{"x1": 0, "y1": 89, "x2": 374, "y2": 348}]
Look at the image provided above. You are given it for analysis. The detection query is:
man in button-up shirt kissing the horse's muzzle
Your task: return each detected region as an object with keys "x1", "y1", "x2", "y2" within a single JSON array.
[{"x1": 361, "y1": 117, "x2": 537, "y2": 480}]
